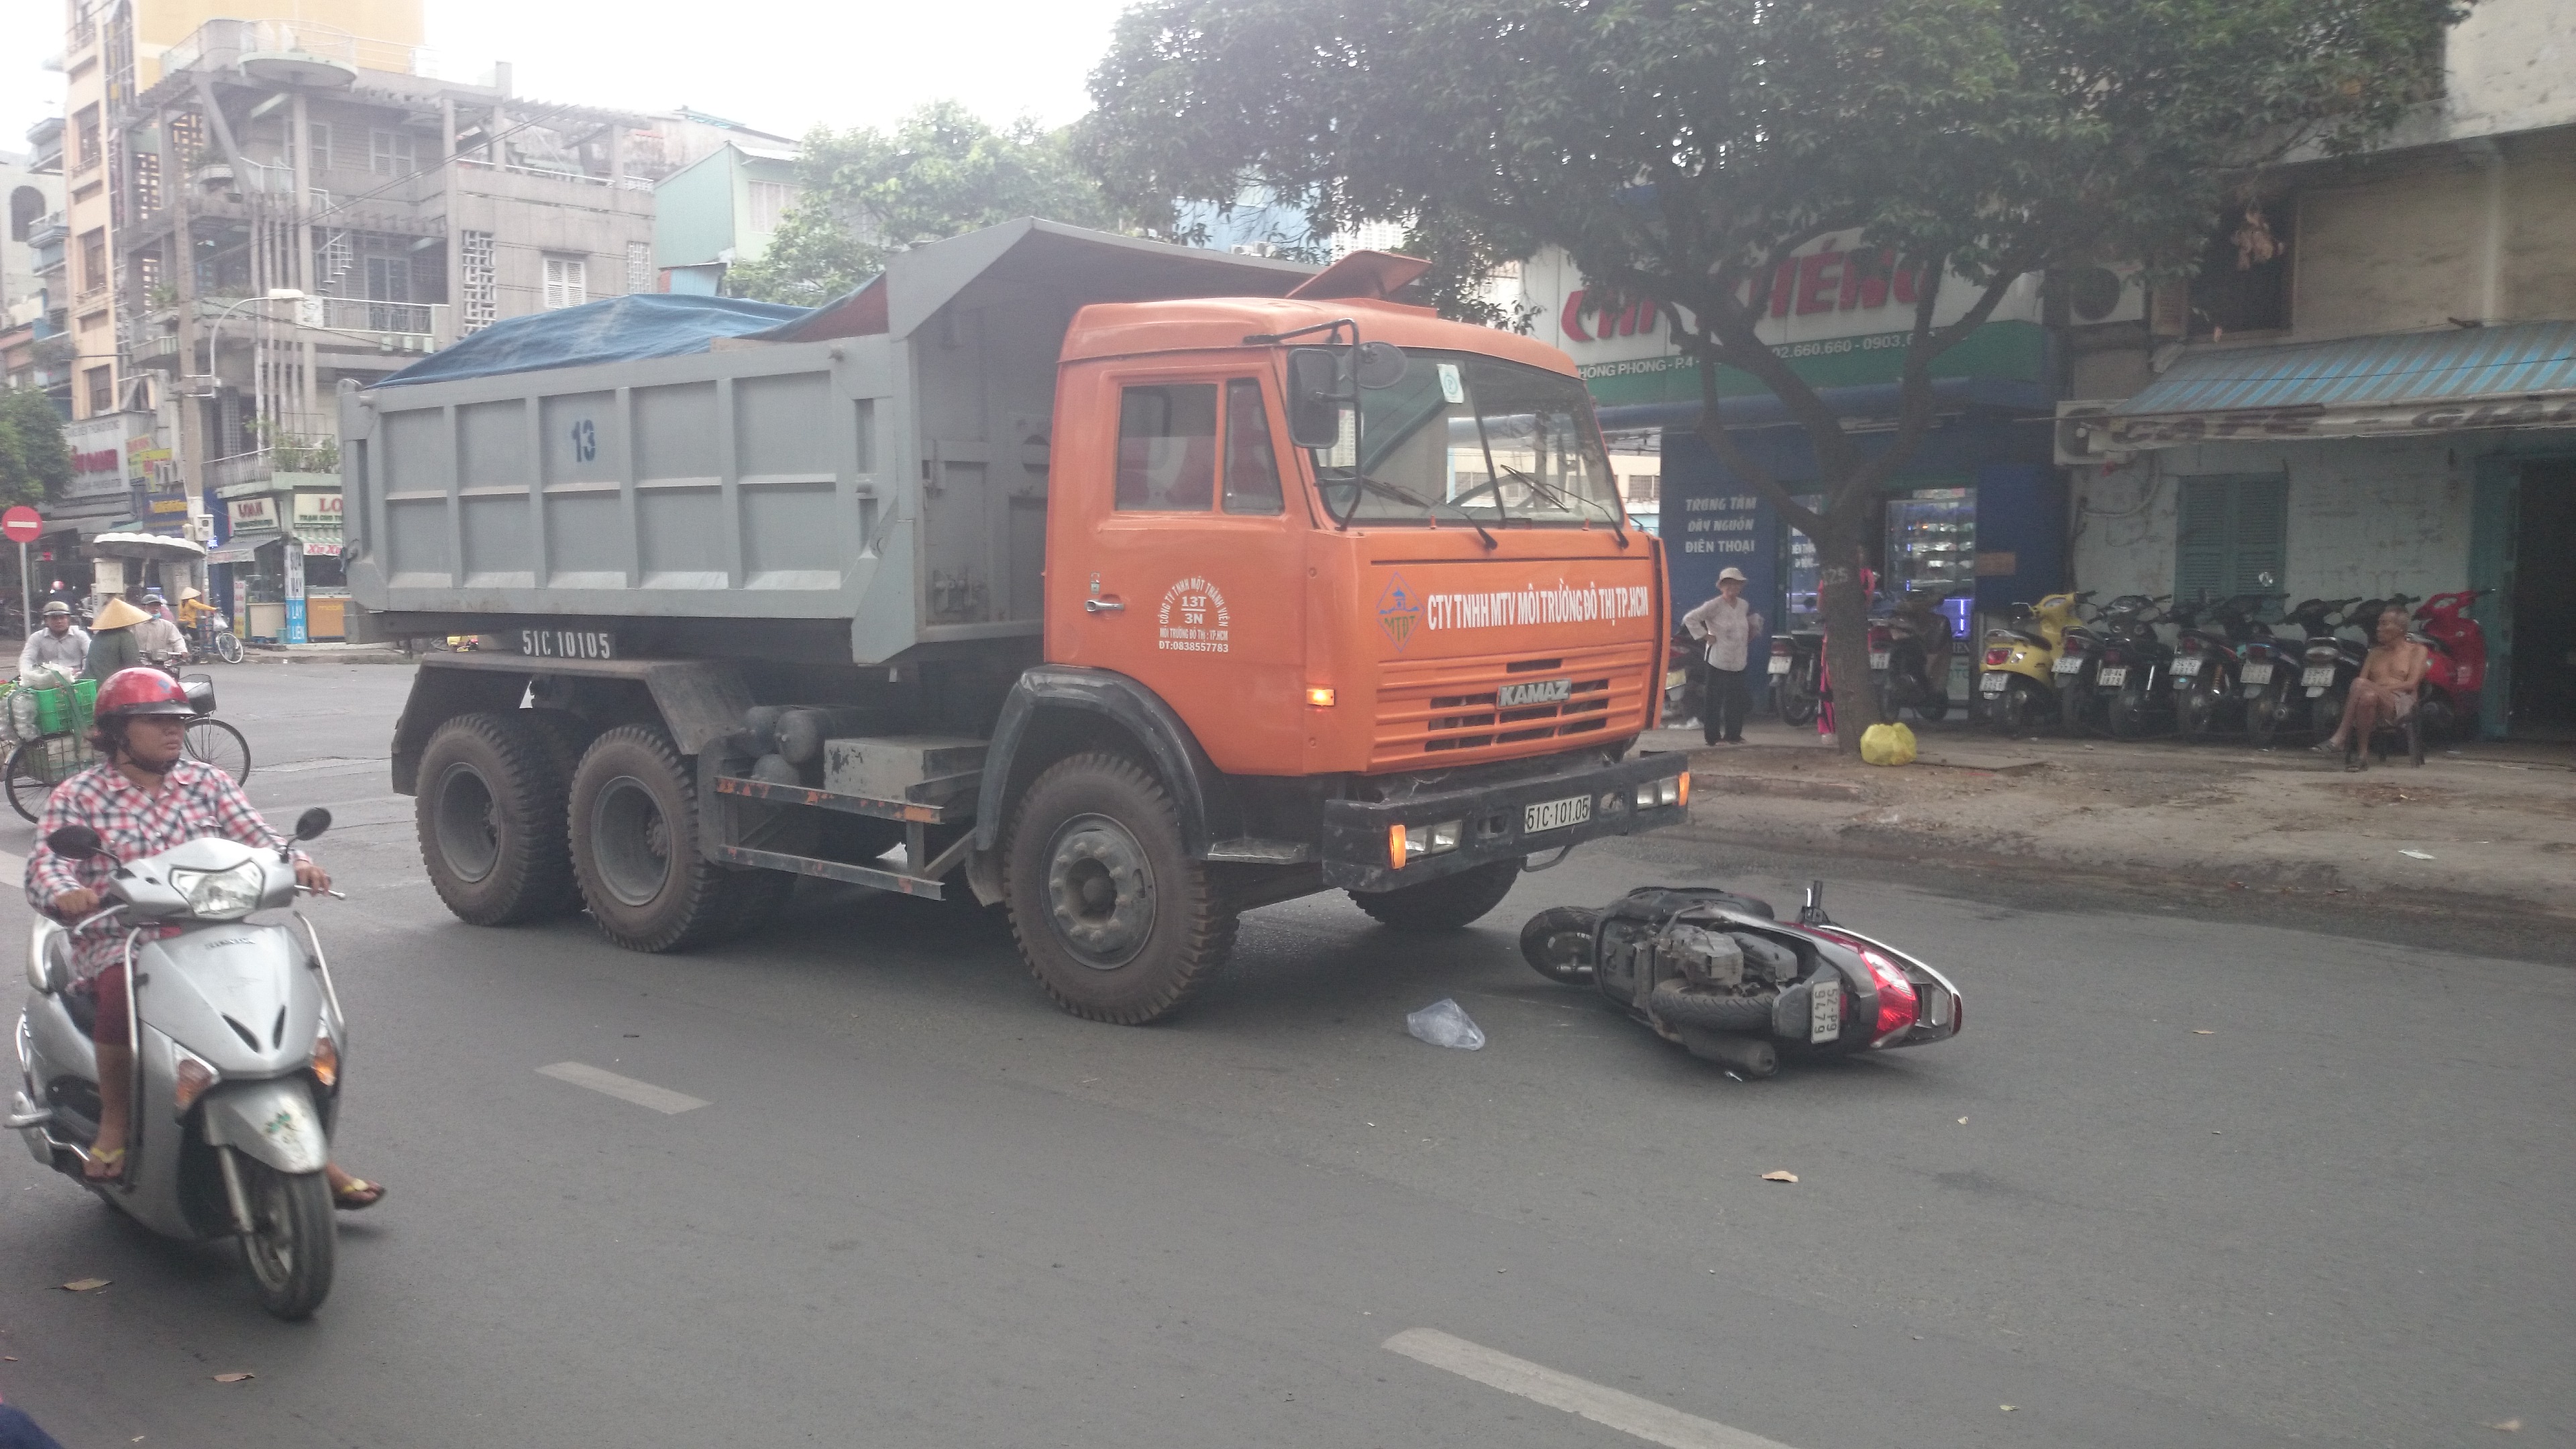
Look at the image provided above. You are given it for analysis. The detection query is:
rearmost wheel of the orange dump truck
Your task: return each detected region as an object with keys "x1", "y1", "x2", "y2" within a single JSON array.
[{"x1": 412, "y1": 712, "x2": 580, "y2": 926}]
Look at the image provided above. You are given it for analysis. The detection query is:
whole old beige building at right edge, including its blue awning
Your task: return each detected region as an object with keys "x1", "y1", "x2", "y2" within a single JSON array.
[{"x1": 2055, "y1": 0, "x2": 2576, "y2": 737}]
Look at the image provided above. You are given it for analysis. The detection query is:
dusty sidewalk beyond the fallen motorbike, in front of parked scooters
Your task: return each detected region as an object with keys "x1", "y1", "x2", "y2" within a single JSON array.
[{"x1": 1641, "y1": 719, "x2": 2576, "y2": 920}]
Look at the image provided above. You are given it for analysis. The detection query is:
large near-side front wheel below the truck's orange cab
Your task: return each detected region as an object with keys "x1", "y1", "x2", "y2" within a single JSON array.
[{"x1": 1002, "y1": 753, "x2": 1234, "y2": 1026}]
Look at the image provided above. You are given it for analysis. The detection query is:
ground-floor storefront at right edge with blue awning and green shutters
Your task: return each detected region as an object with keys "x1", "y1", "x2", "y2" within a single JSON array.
[{"x1": 2074, "y1": 322, "x2": 2576, "y2": 740}]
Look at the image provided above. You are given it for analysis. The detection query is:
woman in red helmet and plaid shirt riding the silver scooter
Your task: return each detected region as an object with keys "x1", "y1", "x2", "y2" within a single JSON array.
[{"x1": 25, "y1": 667, "x2": 384, "y2": 1212}]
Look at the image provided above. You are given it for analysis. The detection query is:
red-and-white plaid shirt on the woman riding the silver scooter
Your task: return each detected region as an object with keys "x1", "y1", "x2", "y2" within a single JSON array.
[{"x1": 25, "y1": 758, "x2": 283, "y2": 979}]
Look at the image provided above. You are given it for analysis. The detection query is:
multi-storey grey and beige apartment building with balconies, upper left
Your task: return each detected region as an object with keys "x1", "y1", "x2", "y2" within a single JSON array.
[{"x1": 49, "y1": 0, "x2": 669, "y2": 637}]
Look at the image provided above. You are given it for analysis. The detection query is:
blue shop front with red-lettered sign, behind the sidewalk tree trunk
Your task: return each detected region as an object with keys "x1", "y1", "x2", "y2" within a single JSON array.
[{"x1": 1522, "y1": 235, "x2": 2081, "y2": 629}]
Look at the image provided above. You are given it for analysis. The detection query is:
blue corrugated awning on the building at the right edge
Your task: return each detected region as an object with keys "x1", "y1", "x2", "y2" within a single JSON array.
[{"x1": 2107, "y1": 322, "x2": 2576, "y2": 449}]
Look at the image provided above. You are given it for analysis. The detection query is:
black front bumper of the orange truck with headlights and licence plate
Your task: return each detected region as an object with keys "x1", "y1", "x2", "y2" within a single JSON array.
[{"x1": 1324, "y1": 755, "x2": 1690, "y2": 892}]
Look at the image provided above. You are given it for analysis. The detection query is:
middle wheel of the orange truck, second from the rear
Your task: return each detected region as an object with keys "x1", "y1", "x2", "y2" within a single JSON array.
[{"x1": 570, "y1": 724, "x2": 734, "y2": 951}]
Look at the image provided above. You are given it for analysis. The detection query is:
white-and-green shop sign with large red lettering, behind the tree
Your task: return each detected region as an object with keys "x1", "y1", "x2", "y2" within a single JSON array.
[{"x1": 1522, "y1": 232, "x2": 2048, "y2": 407}]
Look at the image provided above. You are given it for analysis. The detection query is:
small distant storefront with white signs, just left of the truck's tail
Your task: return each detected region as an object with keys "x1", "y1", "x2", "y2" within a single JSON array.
[{"x1": 209, "y1": 472, "x2": 347, "y2": 645}]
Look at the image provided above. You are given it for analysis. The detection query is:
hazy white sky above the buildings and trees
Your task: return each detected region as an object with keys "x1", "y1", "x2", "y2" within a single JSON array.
[{"x1": 0, "y1": 0, "x2": 1148, "y2": 152}]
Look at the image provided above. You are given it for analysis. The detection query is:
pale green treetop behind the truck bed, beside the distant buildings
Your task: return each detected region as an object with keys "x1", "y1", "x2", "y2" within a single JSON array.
[{"x1": 727, "y1": 101, "x2": 1118, "y2": 307}]
